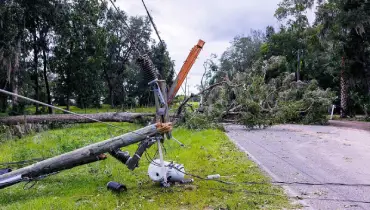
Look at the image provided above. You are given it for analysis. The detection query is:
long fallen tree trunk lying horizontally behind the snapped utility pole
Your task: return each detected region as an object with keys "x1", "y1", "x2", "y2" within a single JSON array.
[{"x1": 0, "y1": 112, "x2": 155, "y2": 125}]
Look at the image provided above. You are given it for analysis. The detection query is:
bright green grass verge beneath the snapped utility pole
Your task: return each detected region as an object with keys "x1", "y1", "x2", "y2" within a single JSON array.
[{"x1": 0, "y1": 123, "x2": 291, "y2": 209}]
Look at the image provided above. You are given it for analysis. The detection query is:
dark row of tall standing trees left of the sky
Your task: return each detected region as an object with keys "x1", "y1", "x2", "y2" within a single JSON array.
[{"x1": 0, "y1": 0, "x2": 174, "y2": 113}]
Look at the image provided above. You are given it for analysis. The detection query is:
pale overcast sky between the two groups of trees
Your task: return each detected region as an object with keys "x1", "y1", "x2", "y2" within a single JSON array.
[{"x1": 115, "y1": 0, "x2": 314, "y2": 93}]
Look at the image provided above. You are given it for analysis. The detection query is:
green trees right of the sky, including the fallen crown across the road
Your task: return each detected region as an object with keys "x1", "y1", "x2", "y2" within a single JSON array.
[{"x1": 200, "y1": 0, "x2": 370, "y2": 124}]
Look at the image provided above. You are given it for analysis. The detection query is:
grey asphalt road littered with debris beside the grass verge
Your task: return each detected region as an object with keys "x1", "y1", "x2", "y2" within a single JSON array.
[{"x1": 225, "y1": 125, "x2": 370, "y2": 209}]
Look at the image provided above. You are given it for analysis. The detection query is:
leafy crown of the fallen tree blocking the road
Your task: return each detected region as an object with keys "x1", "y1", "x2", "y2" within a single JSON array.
[{"x1": 178, "y1": 55, "x2": 335, "y2": 129}]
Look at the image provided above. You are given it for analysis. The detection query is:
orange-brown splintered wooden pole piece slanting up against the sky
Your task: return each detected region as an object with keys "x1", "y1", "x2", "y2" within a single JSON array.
[{"x1": 167, "y1": 40, "x2": 205, "y2": 104}]
